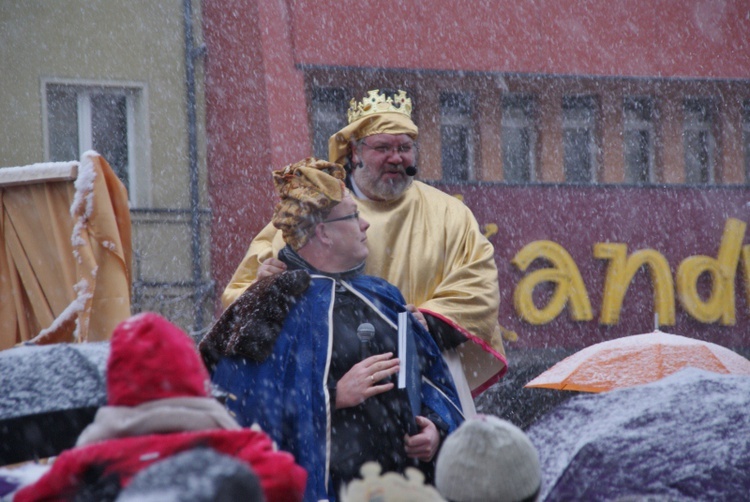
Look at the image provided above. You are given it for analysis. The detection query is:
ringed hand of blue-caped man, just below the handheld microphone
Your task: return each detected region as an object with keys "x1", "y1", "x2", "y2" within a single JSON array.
[{"x1": 336, "y1": 352, "x2": 399, "y2": 410}]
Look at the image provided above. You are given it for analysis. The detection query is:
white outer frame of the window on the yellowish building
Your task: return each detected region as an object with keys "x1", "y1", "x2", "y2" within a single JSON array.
[{"x1": 41, "y1": 78, "x2": 152, "y2": 207}]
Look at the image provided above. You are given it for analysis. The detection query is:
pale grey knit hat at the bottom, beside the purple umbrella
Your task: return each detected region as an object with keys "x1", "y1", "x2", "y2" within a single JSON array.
[{"x1": 435, "y1": 415, "x2": 541, "y2": 502}]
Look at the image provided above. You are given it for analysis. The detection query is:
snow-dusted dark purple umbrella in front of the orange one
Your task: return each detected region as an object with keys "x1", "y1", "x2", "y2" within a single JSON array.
[{"x1": 528, "y1": 368, "x2": 750, "y2": 501}]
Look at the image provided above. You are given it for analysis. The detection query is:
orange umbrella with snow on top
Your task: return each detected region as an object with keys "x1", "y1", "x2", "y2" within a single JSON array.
[{"x1": 525, "y1": 330, "x2": 750, "y2": 392}]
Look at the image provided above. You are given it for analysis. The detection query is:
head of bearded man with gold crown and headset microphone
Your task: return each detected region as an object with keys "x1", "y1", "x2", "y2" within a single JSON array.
[{"x1": 328, "y1": 89, "x2": 419, "y2": 200}]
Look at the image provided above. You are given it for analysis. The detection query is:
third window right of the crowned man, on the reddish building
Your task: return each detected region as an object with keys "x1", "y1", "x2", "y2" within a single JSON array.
[{"x1": 562, "y1": 96, "x2": 599, "y2": 183}]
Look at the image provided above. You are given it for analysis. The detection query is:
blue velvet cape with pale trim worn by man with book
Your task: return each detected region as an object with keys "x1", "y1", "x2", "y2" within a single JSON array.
[{"x1": 212, "y1": 275, "x2": 463, "y2": 501}]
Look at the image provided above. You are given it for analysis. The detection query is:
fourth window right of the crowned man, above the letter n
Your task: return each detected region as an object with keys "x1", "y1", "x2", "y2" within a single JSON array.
[{"x1": 623, "y1": 97, "x2": 654, "y2": 183}]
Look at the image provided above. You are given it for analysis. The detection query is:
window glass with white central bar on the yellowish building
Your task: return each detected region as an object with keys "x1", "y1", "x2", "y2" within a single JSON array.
[{"x1": 44, "y1": 83, "x2": 143, "y2": 203}]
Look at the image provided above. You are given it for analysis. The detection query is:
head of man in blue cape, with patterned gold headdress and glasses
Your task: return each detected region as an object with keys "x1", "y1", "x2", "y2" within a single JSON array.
[{"x1": 272, "y1": 158, "x2": 370, "y2": 273}]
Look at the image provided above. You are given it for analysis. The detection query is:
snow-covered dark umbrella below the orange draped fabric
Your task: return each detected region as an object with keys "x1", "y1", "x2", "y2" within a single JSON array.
[{"x1": 0, "y1": 342, "x2": 109, "y2": 465}]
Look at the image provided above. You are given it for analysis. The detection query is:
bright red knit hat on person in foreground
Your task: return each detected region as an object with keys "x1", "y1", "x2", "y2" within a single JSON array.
[{"x1": 107, "y1": 312, "x2": 209, "y2": 406}]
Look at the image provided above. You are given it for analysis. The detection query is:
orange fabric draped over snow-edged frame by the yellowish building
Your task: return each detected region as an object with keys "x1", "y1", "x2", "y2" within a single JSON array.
[{"x1": 0, "y1": 152, "x2": 132, "y2": 349}]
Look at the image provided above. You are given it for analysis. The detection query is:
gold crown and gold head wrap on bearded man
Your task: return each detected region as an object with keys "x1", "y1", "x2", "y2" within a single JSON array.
[{"x1": 328, "y1": 89, "x2": 419, "y2": 165}]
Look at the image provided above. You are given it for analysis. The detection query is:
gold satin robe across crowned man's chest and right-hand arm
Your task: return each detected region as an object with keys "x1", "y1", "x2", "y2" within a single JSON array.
[{"x1": 359, "y1": 181, "x2": 504, "y2": 355}]
